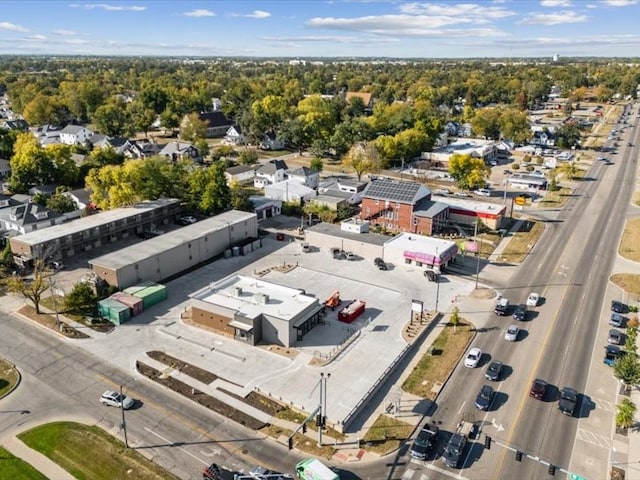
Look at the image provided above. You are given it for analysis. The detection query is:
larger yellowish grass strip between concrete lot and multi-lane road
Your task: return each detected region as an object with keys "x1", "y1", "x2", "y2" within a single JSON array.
[{"x1": 402, "y1": 320, "x2": 473, "y2": 400}]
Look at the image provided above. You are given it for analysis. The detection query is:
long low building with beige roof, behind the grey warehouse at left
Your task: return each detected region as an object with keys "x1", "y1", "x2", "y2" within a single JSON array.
[{"x1": 11, "y1": 198, "x2": 181, "y2": 266}]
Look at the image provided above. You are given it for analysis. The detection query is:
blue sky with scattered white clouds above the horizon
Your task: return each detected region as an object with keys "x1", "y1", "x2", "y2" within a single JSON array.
[{"x1": 0, "y1": 0, "x2": 640, "y2": 58}]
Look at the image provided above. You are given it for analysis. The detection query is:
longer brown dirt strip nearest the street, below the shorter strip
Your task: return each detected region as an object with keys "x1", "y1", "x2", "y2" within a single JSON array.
[{"x1": 136, "y1": 361, "x2": 268, "y2": 430}]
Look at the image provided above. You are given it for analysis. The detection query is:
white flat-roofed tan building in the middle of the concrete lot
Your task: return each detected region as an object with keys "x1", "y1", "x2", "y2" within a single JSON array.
[{"x1": 191, "y1": 275, "x2": 323, "y2": 347}]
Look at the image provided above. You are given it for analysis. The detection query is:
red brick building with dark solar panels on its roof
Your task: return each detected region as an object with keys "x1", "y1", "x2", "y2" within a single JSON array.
[{"x1": 360, "y1": 178, "x2": 449, "y2": 235}]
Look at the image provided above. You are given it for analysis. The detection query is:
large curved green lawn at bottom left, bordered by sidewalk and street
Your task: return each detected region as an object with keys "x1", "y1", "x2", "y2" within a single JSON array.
[{"x1": 18, "y1": 422, "x2": 176, "y2": 480}]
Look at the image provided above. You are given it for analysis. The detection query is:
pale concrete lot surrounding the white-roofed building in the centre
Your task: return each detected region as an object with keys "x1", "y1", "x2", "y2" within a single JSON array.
[{"x1": 64, "y1": 229, "x2": 473, "y2": 432}]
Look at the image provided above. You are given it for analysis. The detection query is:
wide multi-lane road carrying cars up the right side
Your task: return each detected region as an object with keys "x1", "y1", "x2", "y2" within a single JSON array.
[{"x1": 404, "y1": 106, "x2": 638, "y2": 480}]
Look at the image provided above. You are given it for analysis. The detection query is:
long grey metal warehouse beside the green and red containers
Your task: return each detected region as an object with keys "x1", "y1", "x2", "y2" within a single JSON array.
[{"x1": 89, "y1": 210, "x2": 260, "y2": 289}]
